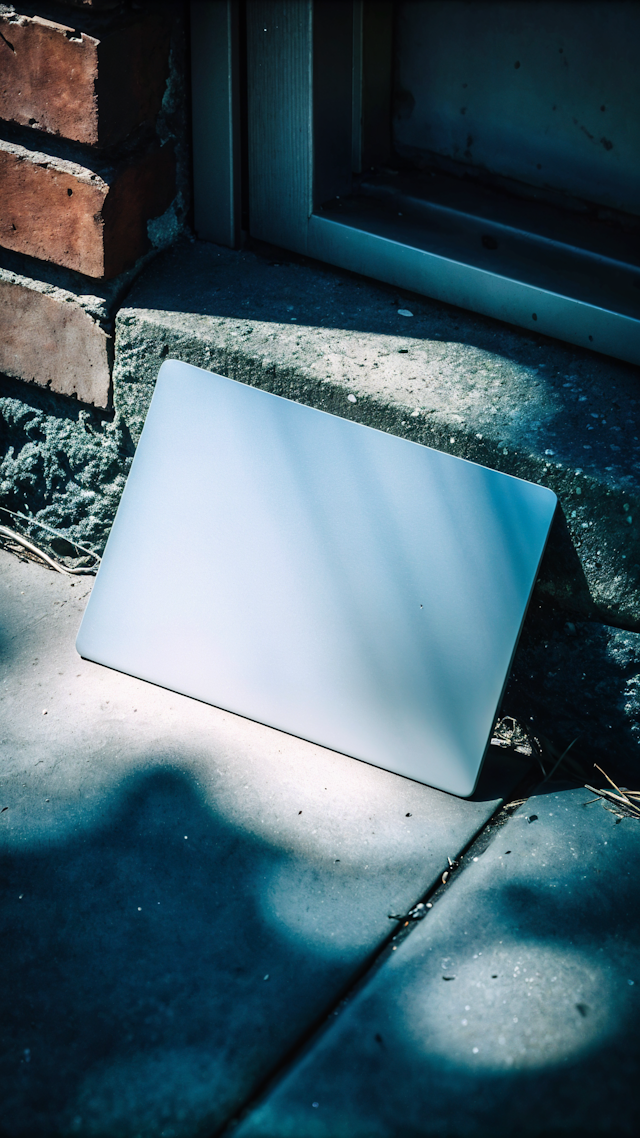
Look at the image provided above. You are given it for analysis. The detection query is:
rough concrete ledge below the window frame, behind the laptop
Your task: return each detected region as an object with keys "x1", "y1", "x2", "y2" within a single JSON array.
[{"x1": 114, "y1": 242, "x2": 640, "y2": 629}]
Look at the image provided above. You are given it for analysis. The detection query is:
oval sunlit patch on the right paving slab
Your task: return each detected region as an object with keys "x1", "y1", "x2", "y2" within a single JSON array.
[{"x1": 401, "y1": 941, "x2": 625, "y2": 1071}]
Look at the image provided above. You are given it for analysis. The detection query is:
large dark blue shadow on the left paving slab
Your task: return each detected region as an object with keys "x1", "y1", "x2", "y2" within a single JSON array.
[{"x1": 0, "y1": 756, "x2": 382, "y2": 1138}]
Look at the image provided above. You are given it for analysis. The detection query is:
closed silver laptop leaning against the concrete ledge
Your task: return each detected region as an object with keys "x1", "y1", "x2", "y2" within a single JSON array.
[{"x1": 76, "y1": 360, "x2": 556, "y2": 797}]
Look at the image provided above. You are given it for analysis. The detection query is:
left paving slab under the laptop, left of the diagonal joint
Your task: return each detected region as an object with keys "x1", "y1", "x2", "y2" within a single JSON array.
[{"x1": 0, "y1": 551, "x2": 524, "y2": 1138}]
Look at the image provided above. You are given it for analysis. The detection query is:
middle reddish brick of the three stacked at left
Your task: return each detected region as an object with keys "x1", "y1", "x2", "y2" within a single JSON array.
[{"x1": 0, "y1": 140, "x2": 175, "y2": 278}]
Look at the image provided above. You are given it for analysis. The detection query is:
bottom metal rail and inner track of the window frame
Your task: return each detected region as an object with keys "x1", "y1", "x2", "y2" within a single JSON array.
[{"x1": 306, "y1": 172, "x2": 640, "y2": 364}]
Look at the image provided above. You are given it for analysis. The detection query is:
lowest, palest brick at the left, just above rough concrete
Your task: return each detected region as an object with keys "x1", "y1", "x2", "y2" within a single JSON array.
[{"x1": 0, "y1": 274, "x2": 110, "y2": 407}]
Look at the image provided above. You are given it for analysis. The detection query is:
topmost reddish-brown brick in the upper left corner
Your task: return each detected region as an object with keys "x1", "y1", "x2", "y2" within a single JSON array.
[{"x1": 0, "y1": 5, "x2": 170, "y2": 146}]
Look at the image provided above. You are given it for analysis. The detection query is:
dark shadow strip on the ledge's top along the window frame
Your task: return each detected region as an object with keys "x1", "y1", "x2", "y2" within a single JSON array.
[{"x1": 138, "y1": 239, "x2": 635, "y2": 384}]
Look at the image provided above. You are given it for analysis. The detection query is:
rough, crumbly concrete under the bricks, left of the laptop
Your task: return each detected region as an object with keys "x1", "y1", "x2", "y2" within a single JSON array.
[{"x1": 0, "y1": 377, "x2": 133, "y2": 553}]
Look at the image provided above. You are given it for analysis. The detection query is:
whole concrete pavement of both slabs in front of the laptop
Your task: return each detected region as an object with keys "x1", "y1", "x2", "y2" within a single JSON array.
[{"x1": 0, "y1": 551, "x2": 640, "y2": 1138}]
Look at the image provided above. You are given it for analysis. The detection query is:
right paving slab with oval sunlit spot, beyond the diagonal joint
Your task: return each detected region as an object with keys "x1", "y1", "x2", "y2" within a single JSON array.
[{"x1": 231, "y1": 789, "x2": 640, "y2": 1138}]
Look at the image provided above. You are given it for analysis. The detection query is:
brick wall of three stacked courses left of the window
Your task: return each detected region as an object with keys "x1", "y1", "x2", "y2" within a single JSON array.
[{"x1": 0, "y1": 0, "x2": 189, "y2": 409}]
